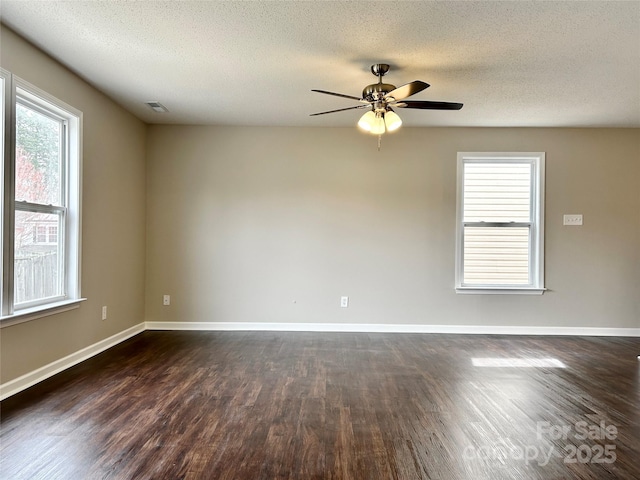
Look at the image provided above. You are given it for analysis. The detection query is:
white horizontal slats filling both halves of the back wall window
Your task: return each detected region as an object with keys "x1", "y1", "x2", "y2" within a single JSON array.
[{"x1": 463, "y1": 161, "x2": 532, "y2": 286}]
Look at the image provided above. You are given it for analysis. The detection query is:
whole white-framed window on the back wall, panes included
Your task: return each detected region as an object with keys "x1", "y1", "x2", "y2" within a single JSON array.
[{"x1": 456, "y1": 153, "x2": 545, "y2": 294}]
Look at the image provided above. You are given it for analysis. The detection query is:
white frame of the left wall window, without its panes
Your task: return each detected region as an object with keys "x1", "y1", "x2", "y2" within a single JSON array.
[{"x1": 0, "y1": 70, "x2": 85, "y2": 328}]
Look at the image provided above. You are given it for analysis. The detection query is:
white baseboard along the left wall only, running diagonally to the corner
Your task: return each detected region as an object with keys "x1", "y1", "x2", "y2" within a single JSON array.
[{"x1": 0, "y1": 323, "x2": 145, "y2": 400}]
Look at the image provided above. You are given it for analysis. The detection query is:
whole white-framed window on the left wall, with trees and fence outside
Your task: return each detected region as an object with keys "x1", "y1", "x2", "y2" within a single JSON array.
[{"x1": 2, "y1": 71, "x2": 82, "y2": 325}]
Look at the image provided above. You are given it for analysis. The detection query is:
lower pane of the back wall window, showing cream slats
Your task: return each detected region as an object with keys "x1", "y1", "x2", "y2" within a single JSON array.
[{"x1": 463, "y1": 227, "x2": 529, "y2": 285}]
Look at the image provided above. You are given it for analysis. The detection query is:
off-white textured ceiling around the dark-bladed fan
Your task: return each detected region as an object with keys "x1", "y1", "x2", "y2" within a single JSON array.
[{"x1": 0, "y1": 0, "x2": 640, "y2": 127}]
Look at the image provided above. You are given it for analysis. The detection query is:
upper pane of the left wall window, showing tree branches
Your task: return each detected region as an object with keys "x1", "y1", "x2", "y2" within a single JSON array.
[{"x1": 15, "y1": 104, "x2": 62, "y2": 205}]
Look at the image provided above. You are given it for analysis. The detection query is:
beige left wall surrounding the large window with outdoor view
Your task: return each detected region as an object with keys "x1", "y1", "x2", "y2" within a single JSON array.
[{"x1": 0, "y1": 26, "x2": 146, "y2": 383}]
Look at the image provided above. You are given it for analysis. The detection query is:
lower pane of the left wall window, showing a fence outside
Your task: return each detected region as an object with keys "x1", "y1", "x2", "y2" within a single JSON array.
[{"x1": 14, "y1": 211, "x2": 62, "y2": 304}]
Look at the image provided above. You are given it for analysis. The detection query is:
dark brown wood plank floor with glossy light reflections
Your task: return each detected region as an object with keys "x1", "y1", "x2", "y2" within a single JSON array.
[{"x1": 0, "y1": 332, "x2": 640, "y2": 480}]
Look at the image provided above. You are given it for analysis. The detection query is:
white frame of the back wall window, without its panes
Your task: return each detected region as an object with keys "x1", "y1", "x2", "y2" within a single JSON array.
[{"x1": 455, "y1": 152, "x2": 545, "y2": 295}]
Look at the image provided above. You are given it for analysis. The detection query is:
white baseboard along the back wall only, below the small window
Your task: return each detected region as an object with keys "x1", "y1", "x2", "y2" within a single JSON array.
[{"x1": 145, "y1": 322, "x2": 640, "y2": 337}]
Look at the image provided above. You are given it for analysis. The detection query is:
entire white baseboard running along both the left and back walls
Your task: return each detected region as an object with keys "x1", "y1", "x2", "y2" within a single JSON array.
[{"x1": 0, "y1": 322, "x2": 640, "y2": 400}]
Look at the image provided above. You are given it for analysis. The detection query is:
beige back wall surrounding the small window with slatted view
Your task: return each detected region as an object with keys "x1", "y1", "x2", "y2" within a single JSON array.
[{"x1": 146, "y1": 126, "x2": 640, "y2": 328}]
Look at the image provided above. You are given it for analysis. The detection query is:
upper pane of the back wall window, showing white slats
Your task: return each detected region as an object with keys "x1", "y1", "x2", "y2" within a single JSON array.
[{"x1": 463, "y1": 163, "x2": 531, "y2": 222}]
